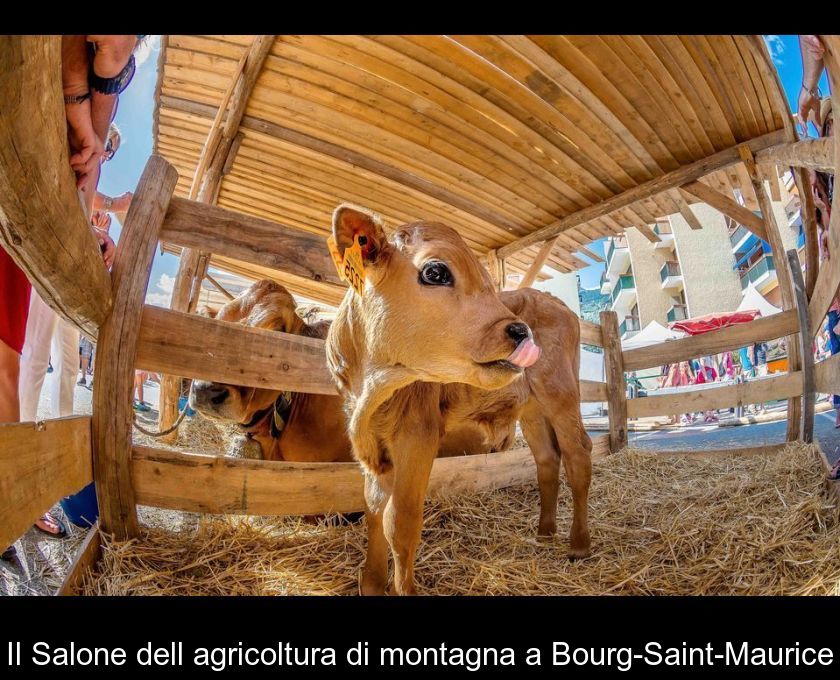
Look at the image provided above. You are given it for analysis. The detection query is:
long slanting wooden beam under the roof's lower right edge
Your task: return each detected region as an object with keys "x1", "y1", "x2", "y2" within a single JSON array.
[{"x1": 492, "y1": 130, "x2": 786, "y2": 257}]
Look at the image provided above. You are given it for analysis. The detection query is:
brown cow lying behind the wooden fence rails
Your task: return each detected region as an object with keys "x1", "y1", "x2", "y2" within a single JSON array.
[{"x1": 189, "y1": 279, "x2": 353, "y2": 463}]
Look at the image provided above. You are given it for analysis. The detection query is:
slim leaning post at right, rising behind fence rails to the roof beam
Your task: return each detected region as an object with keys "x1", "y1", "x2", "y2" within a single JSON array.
[{"x1": 738, "y1": 145, "x2": 802, "y2": 441}]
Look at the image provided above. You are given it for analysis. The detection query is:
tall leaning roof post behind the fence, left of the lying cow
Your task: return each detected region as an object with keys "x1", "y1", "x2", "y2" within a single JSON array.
[{"x1": 159, "y1": 35, "x2": 276, "y2": 442}]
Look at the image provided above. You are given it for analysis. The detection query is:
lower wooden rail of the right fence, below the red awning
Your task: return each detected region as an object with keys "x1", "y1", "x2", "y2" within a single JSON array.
[{"x1": 627, "y1": 371, "x2": 802, "y2": 418}]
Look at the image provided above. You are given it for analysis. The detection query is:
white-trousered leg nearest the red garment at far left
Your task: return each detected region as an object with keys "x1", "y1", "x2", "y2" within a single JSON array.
[{"x1": 18, "y1": 290, "x2": 58, "y2": 422}]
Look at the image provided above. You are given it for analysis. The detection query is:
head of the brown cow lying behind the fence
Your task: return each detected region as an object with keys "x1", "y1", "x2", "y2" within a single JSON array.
[{"x1": 190, "y1": 279, "x2": 307, "y2": 425}]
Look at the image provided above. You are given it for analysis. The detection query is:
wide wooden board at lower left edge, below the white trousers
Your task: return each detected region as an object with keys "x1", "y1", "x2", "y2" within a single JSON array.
[{"x1": 0, "y1": 418, "x2": 92, "y2": 550}]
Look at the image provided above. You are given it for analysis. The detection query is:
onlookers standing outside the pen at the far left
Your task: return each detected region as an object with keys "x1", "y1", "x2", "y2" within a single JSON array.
[{"x1": 0, "y1": 35, "x2": 145, "y2": 559}]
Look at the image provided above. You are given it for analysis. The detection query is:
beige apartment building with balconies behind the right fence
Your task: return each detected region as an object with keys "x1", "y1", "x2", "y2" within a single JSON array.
[{"x1": 601, "y1": 185, "x2": 798, "y2": 339}]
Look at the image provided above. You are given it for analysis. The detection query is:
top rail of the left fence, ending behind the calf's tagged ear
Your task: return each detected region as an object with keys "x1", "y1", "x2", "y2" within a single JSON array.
[{"x1": 160, "y1": 198, "x2": 344, "y2": 284}]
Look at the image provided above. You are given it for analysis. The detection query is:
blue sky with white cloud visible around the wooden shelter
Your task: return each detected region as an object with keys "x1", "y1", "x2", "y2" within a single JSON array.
[{"x1": 110, "y1": 35, "x2": 828, "y2": 304}]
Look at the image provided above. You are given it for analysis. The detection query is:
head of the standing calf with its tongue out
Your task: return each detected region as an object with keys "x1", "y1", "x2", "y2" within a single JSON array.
[{"x1": 328, "y1": 205, "x2": 540, "y2": 392}]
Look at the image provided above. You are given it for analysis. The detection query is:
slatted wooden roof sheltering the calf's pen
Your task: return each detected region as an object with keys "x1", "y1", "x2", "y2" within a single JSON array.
[{"x1": 154, "y1": 35, "x2": 788, "y2": 302}]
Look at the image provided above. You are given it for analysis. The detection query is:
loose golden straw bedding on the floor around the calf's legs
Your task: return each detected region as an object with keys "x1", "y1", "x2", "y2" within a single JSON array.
[{"x1": 84, "y1": 444, "x2": 840, "y2": 595}]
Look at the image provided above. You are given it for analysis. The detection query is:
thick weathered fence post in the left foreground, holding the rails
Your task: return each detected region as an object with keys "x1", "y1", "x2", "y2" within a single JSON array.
[{"x1": 92, "y1": 156, "x2": 178, "y2": 540}]
